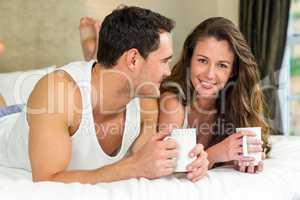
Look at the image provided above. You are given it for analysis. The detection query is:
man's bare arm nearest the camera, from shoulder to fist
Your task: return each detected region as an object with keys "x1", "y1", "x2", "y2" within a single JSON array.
[{"x1": 27, "y1": 72, "x2": 176, "y2": 184}]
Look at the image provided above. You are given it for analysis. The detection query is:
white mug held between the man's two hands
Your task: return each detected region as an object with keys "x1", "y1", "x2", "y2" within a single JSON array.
[{"x1": 170, "y1": 128, "x2": 196, "y2": 172}]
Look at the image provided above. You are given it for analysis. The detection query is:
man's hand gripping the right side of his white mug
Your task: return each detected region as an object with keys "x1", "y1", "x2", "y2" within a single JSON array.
[{"x1": 187, "y1": 144, "x2": 209, "y2": 182}]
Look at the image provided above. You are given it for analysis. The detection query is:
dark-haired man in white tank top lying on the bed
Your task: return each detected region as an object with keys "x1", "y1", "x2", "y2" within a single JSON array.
[{"x1": 1, "y1": 7, "x2": 206, "y2": 184}]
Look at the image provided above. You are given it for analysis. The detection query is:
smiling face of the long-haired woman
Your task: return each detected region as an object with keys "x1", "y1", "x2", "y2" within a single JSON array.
[{"x1": 191, "y1": 37, "x2": 234, "y2": 98}]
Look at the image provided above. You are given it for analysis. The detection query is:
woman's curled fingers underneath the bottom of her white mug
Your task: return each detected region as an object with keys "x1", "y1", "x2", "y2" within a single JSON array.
[{"x1": 234, "y1": 152, "x2": 266, "y2": 174}]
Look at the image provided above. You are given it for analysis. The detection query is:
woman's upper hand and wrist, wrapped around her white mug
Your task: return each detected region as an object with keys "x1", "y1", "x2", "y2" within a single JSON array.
[{"x1": 207, "y1": 131, "x2": 262, "y2": 167}]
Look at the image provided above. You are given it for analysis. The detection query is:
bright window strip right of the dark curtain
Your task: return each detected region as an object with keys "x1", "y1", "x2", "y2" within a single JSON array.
[{"x1": 279, "y1": 0, "x2": 300, "y2": 135}]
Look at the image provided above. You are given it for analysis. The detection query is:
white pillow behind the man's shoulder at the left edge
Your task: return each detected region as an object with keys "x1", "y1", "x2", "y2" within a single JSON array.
[{"x1": 0, "y1": 65, "x2": 56, "y2": 106}]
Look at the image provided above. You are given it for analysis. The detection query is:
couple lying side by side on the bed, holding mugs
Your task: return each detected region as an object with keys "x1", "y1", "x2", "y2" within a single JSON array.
[{"x1": 0, "y1": 7, "x2": 269, "y2": 184}]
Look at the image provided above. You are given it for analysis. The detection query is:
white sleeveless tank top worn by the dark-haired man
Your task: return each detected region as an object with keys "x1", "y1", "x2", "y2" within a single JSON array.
[{"x1": 0, "y1": 61, "x2": 141, "y2": 170}]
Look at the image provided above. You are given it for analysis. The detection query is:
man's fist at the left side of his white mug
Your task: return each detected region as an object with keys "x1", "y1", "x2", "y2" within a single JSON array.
[{"x1": 133, "y1": 132, "x2": 178, "y2": 179}]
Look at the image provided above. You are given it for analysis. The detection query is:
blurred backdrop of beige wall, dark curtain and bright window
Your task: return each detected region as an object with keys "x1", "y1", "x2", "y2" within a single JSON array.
[{"x1": 0, "y1": 0, "x2": 300, "y2": 135}]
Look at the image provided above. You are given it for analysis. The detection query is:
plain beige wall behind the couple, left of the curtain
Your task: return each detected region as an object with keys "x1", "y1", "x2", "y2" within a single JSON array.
[{"x1": 0, "y1": 0, "x2": 238, "y2": 72}]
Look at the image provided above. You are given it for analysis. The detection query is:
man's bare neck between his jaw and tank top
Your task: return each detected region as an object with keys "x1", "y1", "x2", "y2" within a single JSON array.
[{"x1": 92, "y1": 64, "x2": 134, "y2": 116}]
